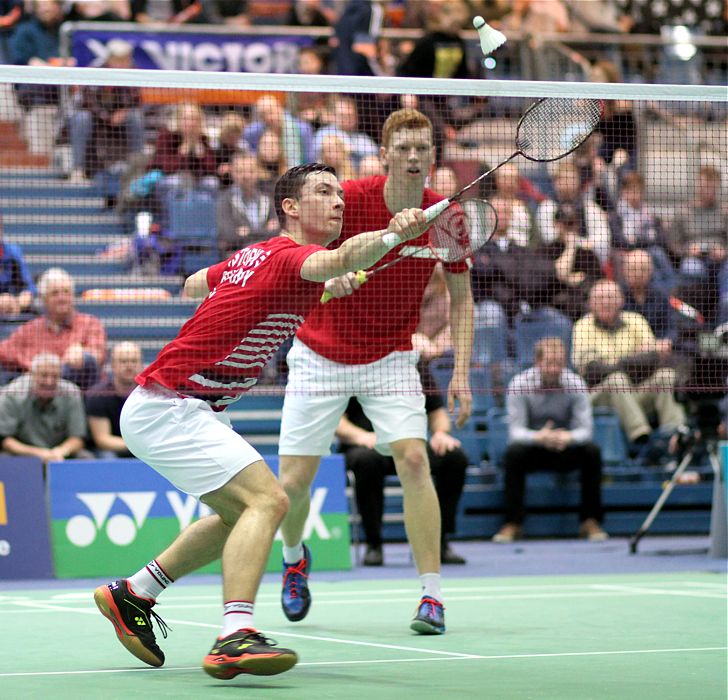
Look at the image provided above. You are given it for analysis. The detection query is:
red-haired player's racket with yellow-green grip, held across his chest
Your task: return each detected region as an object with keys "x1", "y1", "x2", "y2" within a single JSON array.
[{"x1": 321, "y1": 199, "x2": 498, "y2": 304}]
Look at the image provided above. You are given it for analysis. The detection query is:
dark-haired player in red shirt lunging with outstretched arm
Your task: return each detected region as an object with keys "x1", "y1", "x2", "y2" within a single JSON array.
[{"x1": 94, "y1": 163, "x2": 427, "y2": 679}]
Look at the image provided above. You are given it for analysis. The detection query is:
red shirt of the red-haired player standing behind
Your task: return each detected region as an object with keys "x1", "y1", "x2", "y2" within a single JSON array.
[{"x1": 297, "y1": 175, "x2": 468, "y2": 365}]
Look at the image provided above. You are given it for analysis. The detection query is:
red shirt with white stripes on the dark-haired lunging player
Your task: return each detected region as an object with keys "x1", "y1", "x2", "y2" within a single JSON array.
[{"x1": 136, "y1": 236, "x2": 325, "y2": 410}]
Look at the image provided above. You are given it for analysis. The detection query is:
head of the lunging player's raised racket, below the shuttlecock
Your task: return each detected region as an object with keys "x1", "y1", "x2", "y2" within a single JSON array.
[{"x1": 516, "y1": 97, "x2": 604, "y2": 163}]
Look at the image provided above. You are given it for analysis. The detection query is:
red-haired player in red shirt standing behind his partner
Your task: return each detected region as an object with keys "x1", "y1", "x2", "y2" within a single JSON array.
[{"x1": 279, "y1": 109, "x2": 473, "y2": 634}]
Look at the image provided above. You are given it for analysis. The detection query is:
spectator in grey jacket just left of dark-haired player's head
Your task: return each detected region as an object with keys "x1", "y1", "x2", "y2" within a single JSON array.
[{"x1": 217, "y1": 153, "x2": 278, "y2": 256}]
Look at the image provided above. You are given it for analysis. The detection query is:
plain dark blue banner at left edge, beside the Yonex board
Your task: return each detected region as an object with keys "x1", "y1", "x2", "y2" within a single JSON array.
[{"x1": 0, "y1": 457, "x2": 53, "y2": 579}]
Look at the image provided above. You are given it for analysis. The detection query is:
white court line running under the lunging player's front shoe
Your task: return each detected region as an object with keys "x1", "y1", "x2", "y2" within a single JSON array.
[{"x1": 0, "y1": 647, "x2": 728, "y2": 678}]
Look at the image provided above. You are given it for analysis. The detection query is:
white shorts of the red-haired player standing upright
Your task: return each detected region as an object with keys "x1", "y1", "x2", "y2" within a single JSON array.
[{"x1": 278, "y1": 338, "x2": 427, "y2": 457}]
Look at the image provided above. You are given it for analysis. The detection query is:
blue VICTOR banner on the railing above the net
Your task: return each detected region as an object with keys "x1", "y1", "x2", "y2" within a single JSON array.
[{"x1": 71, "y1": 30, "x2": 314, "y2": 73}]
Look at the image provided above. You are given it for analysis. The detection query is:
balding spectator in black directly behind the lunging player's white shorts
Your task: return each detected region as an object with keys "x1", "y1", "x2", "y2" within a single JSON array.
[{"x1": 86, "y1": 342, "x2": 144, "y2": 459}]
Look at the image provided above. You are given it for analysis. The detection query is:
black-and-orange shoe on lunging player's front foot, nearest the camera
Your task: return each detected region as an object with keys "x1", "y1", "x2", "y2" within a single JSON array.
[{"x1": 202, "y1": 629, "x2": 298, "y2": 681}]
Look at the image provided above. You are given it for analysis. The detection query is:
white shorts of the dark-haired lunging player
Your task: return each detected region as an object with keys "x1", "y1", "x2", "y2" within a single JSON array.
[{"x1": 120, "y1": 384, "x2": 263, "y2": 498}]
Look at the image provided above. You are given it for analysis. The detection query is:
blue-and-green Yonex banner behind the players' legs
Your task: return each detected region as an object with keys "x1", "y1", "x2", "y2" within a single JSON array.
[{"x1": 48, "y1": 455, "x2": 351, "y2": 578}]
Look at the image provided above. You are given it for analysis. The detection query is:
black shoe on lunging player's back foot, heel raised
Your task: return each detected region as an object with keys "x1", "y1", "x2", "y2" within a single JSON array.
[{"x1": 94, "y1": 578, "x2": 168, "y2": 666}]
